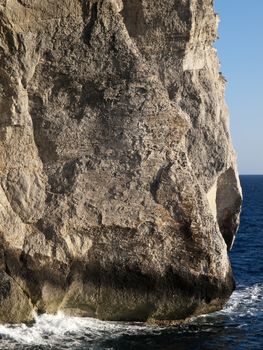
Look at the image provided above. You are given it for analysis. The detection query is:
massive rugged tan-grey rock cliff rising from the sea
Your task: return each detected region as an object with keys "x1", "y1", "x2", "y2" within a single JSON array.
[{"x1": 0, "y1": 0, "x2": 242, "y2": 322}]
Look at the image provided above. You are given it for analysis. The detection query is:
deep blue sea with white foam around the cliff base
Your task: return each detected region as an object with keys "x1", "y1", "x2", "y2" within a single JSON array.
[{"x1": 0, "y1": 175, "x2": 263, "y2": 350}]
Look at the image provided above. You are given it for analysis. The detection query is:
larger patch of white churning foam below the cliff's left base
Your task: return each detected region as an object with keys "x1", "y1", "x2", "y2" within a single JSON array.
[{"x1": 0, "y1": 313, "x2": 153, "y2": 349}]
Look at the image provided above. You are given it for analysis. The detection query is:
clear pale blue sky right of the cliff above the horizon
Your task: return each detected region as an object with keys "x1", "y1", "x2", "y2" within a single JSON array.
[{"x1": 215, "y1": 0, "x2": 263, "y2": 174}]
